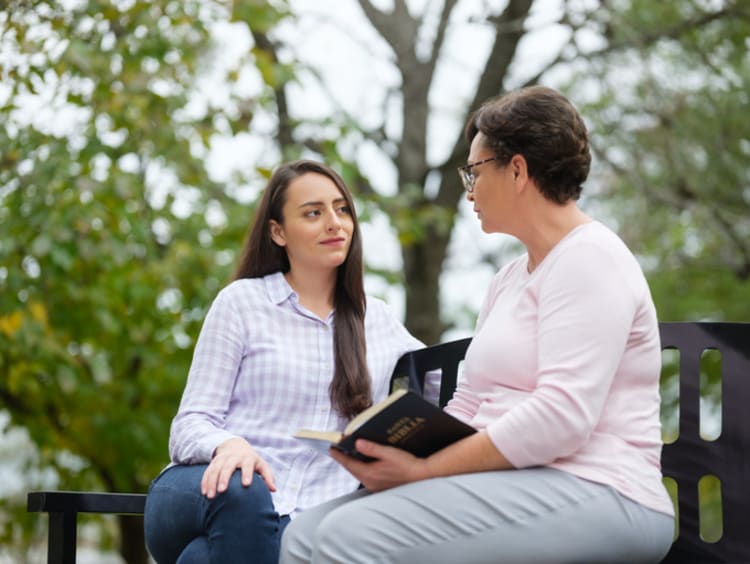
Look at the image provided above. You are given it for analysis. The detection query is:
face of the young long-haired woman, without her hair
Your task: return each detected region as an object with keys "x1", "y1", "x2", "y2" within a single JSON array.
[{"x1": 269, "y1": 172, "x2": 354, "y2": 276}]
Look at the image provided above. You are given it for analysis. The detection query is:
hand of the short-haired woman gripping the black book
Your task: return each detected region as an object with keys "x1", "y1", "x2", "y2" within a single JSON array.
[{"x1": 330, "y1": 439, "x2": 429, "y2": 492}]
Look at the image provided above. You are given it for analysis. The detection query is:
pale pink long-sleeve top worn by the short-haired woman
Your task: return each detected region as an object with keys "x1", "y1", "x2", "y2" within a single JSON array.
[{"x1": 446, "y1": 222, "x2": 674, "y2": 515}]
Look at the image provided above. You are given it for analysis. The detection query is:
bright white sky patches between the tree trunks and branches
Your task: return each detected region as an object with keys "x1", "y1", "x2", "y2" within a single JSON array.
[{"x1": 205, "y1": 0, "x2": 567, "y2": 340}]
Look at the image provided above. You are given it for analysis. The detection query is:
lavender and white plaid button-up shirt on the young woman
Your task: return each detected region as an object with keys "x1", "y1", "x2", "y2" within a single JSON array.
[{"x1": 169, "y1": 273, "x2": 424, "y2": 515}]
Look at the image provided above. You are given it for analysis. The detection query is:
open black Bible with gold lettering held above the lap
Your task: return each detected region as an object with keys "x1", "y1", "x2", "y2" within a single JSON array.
[{"x1": 294, "y1": 390, "x2": 476, "y2": 460}]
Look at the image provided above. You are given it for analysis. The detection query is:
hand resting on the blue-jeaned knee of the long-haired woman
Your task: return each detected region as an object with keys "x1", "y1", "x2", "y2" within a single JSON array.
[{"x1": 201, "y1": 437, "x2": 276, "y2": 499}]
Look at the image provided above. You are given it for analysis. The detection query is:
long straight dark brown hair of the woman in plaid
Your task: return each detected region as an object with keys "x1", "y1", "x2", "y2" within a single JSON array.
[{"x1": 234, "y1": 160, "x2": 372, "y2": 418}]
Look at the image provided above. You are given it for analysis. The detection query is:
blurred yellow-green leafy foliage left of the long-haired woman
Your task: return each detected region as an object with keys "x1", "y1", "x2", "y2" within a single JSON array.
[{"x1": 0, "y1": 0, "x2": 292, "y2": 560}]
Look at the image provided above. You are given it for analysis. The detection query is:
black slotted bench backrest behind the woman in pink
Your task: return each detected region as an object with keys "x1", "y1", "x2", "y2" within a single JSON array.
[{"x1": 394, "y1": 322, "x2": 750, "y2": 564}]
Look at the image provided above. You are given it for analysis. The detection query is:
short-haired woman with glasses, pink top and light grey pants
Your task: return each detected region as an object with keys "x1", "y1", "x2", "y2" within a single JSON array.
[{"x1": 281, "y1": 87, "x2": 674, "y2": 564}]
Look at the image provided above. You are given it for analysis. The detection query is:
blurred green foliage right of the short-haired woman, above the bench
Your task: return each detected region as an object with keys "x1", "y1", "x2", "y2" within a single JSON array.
[{"x1": 571, "y1": 0, "x2": 750, "y2": 321}]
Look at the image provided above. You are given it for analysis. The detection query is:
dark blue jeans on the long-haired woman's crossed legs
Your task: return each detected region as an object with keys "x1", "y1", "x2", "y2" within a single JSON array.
[{"x1": 144, "y1": 464, "x2": 289, "y2": 564}]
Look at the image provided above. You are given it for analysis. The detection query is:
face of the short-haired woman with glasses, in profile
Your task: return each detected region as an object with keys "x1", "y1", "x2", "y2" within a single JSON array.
[{"x1": 466, "y1": 132, "x2": 514, "y2": 233}]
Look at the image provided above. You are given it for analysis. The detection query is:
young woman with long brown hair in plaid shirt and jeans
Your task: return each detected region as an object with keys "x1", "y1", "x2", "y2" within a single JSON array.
[{"x1": 145, "y1": 161, "x2": 423, "y2": 564}]
